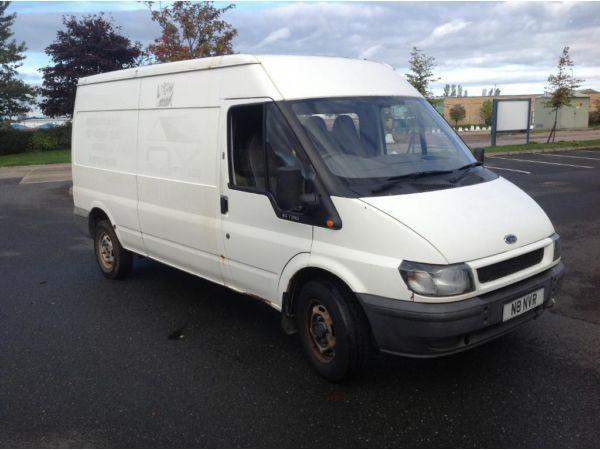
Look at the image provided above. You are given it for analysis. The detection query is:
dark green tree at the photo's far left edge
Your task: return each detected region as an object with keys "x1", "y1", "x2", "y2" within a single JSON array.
[{"x1": 0, "y1": 2, "x2": 35, "y2": 122}]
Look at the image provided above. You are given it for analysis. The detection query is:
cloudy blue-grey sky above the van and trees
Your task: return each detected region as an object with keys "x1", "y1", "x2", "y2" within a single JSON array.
[{"x1": 9, "y1": 2, "x2": 600, "y2": 95}]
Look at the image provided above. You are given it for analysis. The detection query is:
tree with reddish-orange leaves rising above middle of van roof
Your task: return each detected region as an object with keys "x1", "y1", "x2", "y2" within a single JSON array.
[{"x1": 146, "y1": 1, "x2": 237, "y2": 62}]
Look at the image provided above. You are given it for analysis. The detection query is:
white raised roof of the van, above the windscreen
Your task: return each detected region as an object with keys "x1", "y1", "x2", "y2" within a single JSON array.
[{"x1": 78, "y1": 54, "x2": 420, "y2": 99}]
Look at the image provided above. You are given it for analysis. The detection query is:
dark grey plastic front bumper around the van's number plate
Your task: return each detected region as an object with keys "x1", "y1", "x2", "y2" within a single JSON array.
[{"x1": 357, "y1": 263, "x2": 565, "y2": 357}]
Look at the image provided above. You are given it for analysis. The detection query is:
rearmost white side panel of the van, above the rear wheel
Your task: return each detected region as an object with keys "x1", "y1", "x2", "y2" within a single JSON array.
[{"x1": 73, "y1": 80, "x2": 145, "y2": 254}]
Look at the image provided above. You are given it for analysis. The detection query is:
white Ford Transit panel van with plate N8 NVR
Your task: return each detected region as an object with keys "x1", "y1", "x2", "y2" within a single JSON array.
[{"x1": 73, "y1": 55, "x2": 564, "y2": 380}]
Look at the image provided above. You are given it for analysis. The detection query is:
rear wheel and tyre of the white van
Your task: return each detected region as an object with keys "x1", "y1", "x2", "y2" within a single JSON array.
[{"x1": 94, "y1": 220, "x2": 133, "y2": 280}]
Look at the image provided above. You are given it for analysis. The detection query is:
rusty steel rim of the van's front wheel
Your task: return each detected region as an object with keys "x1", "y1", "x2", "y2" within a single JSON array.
[{"x1": 306, "y1": 300, "x2": 336, "y2": 363}]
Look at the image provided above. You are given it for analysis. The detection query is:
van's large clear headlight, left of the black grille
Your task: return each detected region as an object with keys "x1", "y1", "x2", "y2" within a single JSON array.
[{"x1": 399, "y1": 261, "x2": 473, "y2": 297}]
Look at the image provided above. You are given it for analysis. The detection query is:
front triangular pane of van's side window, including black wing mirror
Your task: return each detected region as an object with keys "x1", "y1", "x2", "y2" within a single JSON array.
[{"x1": 266, "y1": 105, "x2": 315, "y2": 211}]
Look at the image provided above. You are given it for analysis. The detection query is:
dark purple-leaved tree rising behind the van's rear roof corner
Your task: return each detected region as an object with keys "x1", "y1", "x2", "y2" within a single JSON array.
[{"x1": 40, "y1": 13, "x2": 142, "y2": 117}]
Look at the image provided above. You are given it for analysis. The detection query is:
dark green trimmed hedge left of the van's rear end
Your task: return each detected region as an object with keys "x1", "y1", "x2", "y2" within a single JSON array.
[{"x1": 0, "y1": 123, "x2": 71, "y2": 155}]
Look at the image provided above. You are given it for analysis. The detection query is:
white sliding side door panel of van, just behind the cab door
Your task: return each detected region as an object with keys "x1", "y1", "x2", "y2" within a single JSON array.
[{"x1": 138, "y1": 71, "x2": 223, "y2": 283}]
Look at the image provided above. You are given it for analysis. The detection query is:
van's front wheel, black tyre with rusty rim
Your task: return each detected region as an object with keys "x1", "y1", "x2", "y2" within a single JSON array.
[{"x1": 296, "y1": 279, "x2": 372, "y2": 382}]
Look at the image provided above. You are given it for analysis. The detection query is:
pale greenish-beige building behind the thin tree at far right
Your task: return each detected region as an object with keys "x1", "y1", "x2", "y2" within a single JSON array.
[{"x1": 533, "y1": 93, "x2": 590, "y2": 130}]
